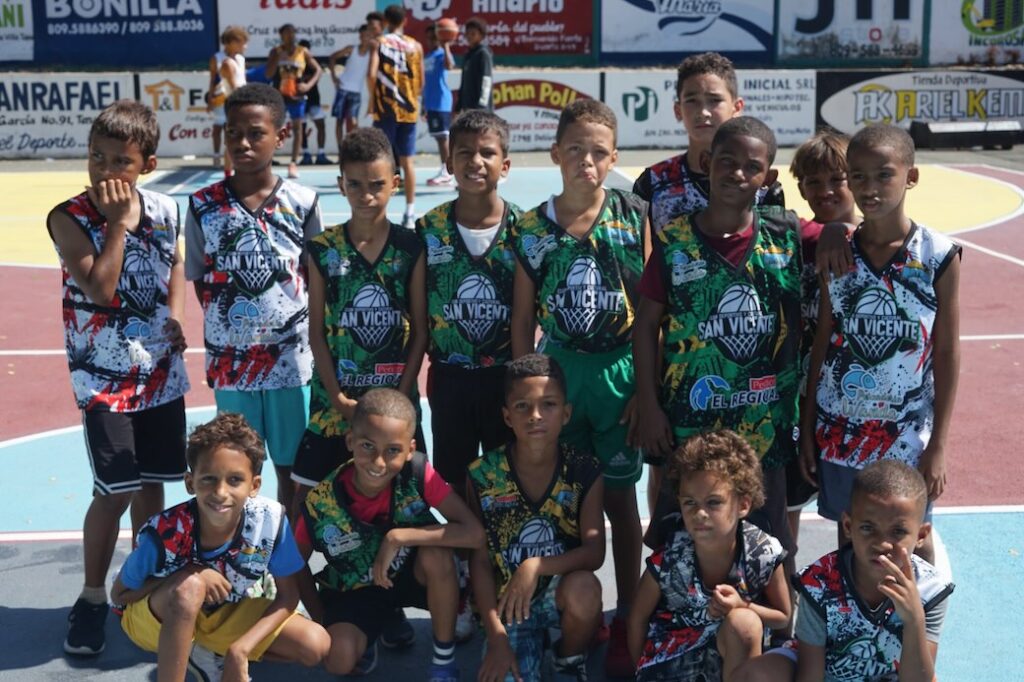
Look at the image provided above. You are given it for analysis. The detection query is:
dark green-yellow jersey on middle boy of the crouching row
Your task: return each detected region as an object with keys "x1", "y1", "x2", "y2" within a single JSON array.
[{"x1": 467, "y1": 444, "x2": 601, "y2": 597}]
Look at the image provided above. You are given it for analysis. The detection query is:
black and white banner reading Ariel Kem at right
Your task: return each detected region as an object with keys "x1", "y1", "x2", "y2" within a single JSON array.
[{"x1": 817, "y1": 71, "x2": 1024, "y2": 134}]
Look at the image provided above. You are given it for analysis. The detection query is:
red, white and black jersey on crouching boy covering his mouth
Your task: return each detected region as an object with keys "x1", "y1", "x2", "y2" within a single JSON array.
[{"x1": 794, "y1": 545, "x2": 953, "y2": 682}]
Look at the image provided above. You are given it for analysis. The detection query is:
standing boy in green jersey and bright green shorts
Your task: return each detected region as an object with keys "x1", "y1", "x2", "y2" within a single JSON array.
[{"x1": 512, "y1": 99, "x2": 649, "y2": 677}]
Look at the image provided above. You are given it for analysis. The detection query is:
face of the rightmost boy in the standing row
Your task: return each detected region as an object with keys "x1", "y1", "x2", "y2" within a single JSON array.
[{"x1": 847, "y1": 146, "x2": 918, "y2": 220}]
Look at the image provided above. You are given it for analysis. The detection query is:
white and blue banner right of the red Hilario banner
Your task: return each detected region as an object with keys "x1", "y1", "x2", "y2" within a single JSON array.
[{"x1": 598, "y1": 0, "x2": 775, "y2": 63}]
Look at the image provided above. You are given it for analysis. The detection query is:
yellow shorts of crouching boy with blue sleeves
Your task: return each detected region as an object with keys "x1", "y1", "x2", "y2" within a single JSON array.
[{"x1": 121, "y1": 596, "x2": 302, "y2": 660}]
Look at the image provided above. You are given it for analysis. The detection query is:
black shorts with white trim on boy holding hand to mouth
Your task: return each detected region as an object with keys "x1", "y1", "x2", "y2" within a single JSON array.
[{"x1": 82, "y1": 397, "x2": 185, "y2": 495}]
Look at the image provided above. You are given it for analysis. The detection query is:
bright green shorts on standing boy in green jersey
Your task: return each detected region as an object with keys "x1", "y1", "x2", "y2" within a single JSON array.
[{"x1": 543, "y1": 343, "x2": 643, "y2": 488}]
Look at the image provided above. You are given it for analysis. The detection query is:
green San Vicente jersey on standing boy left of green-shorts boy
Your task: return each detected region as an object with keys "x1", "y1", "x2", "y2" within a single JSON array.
[{"x1": 416, "y1": 197, "x2": 522, "y2": 369}]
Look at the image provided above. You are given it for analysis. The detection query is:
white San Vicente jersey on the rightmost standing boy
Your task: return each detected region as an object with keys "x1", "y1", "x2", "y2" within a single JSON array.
[{"x1": 815, "y1": 225, "x2": 961, "y2": 469}]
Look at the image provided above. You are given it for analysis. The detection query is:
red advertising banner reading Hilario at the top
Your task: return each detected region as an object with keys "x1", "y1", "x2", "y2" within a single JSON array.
[{"x1": 404, "y1": 0, "x2": 596, "y2": 55}]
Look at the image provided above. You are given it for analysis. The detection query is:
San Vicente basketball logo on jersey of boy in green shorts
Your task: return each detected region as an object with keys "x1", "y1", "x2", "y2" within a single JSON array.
[{"x1": 547, "y1": 256, "x2": 626, "y2": 336}]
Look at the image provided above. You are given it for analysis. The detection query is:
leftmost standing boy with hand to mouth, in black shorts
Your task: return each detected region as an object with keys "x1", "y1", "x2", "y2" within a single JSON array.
[{"x1": 46, "y1": 99, "x2": 188, "y2": 655}]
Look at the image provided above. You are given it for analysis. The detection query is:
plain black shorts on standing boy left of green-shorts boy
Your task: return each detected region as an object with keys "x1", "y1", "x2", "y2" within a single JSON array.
[{"x1": 427, "y1": 363, "x2": 512, "y2": 497}]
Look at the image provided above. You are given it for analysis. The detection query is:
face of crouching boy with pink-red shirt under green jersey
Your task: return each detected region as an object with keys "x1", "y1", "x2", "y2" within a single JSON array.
[{"x1": 345, "y1": 415, "x2": 416, "y2": 491}]
